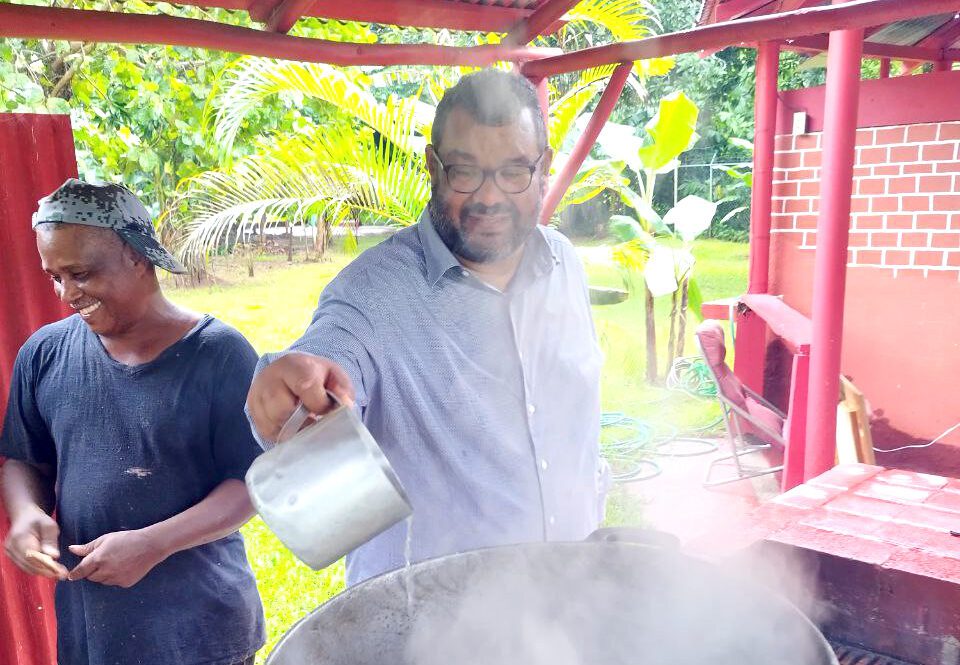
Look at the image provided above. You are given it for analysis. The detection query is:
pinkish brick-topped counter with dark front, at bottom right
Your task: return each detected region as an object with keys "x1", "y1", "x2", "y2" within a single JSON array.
[{"x1": 743, "y1": 464, "x2": 960, "y2": 665}]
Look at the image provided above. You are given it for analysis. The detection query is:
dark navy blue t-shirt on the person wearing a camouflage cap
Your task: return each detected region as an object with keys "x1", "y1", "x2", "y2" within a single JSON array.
[{"x1": 0, "y1": 315, "x2": 264, "y2": 665}]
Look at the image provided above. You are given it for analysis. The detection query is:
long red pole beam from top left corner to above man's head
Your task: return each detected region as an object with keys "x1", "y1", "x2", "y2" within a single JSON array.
[{"x1": 0, "y1": 4, "x2": 558, "y2": 67}]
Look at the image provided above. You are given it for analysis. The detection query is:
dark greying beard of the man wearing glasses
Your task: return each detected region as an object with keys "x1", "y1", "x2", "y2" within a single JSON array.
[{"x1": 427, "y1": 190, "x2": 542, "y2": 263}]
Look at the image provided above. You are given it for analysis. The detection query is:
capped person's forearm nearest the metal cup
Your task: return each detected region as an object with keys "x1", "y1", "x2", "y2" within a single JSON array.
[{"x1": 143, "y1": 479, "x2": 255, "y2": 556}]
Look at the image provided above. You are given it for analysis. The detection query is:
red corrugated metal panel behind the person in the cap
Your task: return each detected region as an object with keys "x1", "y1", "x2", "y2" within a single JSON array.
[{"x1": 0, "y1": 114, "x2": 77, "y2": 665}]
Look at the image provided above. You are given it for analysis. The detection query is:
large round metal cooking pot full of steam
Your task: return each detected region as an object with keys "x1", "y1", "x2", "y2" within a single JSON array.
[{"x1": 267, "y1": 542, "x2": 837, "y2": 665}]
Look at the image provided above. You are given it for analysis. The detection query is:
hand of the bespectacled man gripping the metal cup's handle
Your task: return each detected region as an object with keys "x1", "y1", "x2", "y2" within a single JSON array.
[{"x1": 247, "y1": 352, "x2": 354, "y2": 441}]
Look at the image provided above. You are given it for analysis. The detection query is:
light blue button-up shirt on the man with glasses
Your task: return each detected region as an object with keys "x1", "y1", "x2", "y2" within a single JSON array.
[{"x1": 260, "y1": 213, "x2": 606, "y2": 584}]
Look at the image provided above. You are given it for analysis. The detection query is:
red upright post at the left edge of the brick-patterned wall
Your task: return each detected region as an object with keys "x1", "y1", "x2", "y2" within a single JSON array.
[{"x1": 747, "y1": 42, "x2": 780, "y2": 293}]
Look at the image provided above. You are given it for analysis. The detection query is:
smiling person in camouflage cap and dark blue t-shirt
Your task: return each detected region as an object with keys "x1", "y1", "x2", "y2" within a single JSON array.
[{"x1": 0, "y1": 179, "x2": 263, "y2": 665}]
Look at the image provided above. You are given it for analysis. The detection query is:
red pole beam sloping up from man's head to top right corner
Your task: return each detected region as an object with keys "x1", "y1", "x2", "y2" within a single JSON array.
[{"x1": 523, "y1": 0, "x2": 960, "y2": 78}]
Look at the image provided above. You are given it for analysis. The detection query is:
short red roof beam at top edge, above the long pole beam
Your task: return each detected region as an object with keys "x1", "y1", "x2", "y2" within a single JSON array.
[{"x1": 251, "y1": 0, "x2": 562, "y2": 32}]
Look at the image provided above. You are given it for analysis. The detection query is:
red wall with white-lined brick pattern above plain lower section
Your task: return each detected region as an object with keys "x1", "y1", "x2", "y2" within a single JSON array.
[{"x1": 770, "y1": 120, "x2": 960, "y2": 474}]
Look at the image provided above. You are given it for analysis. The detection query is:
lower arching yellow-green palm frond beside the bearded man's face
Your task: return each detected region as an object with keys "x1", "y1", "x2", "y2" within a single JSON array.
[{"x1": 177, "y1": 118, "x2": 430, "y2": 264}]
